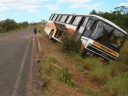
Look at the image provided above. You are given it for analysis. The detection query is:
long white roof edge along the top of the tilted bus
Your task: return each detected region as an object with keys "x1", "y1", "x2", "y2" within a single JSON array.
[{"x1": 53, "y1": 13, "x2": 128, "y2": 34}]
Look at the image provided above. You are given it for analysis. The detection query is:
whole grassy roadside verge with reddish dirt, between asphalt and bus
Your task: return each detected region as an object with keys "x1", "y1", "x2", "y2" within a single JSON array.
[{"x1": 40, "y1": 30, "x2": 128, "y2": 96}]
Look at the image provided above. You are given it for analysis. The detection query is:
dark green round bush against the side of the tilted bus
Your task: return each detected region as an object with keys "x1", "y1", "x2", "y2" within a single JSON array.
[{"x1": 62, "y1": 33, "x2": 81, "y2": 53}]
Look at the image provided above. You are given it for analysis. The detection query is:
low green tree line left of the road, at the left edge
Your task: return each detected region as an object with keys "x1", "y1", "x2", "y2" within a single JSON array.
[{"x1": 0, "y1": 18, "x2": 29, "y2": 33}]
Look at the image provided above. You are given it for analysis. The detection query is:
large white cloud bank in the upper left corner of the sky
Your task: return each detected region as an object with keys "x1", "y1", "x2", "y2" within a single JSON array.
[{"x1": 0, "y1": 0, "x2": 48, "y2": 13}]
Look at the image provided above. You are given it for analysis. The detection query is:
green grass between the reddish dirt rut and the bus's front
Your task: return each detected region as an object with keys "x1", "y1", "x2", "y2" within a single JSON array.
[{"x1": 60, "y1": 41, "x2": 128, "y2": 96}]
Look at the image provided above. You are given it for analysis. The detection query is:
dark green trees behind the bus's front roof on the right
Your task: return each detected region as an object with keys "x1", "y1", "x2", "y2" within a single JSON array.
[{"x1": 90, "y1": 6, "x2": 128, "y2": 31}]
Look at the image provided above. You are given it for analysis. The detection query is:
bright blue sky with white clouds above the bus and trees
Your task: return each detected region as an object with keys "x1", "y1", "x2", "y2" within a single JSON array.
[{"x1": 0, "y1": 0, "x2": 128, "y2": 23}]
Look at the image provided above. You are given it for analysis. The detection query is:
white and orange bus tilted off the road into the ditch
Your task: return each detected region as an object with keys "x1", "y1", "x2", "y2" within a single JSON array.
[{"x1": 44, "y1": 13, "x2": 127, "y2": 61}]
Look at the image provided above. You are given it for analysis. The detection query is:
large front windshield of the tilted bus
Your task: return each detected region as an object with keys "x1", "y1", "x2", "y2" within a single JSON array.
[{"x1": 91, "y1": 21, "x2": 126, "y2": 51}]
